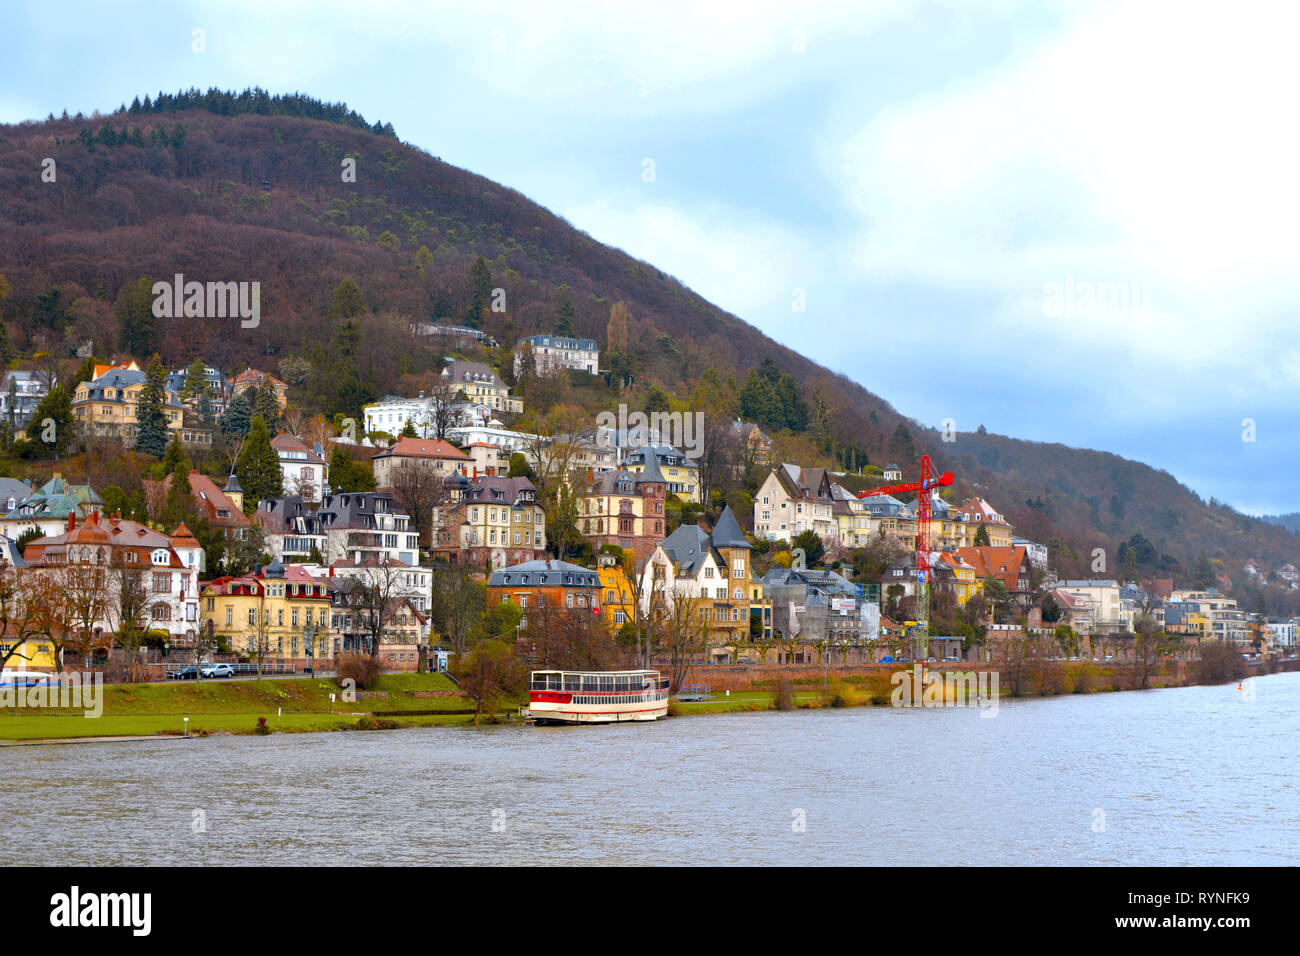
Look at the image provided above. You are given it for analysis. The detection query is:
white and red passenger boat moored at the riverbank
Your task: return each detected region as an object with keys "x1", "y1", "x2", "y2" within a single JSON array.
[{"x1": 528, "y1": 671, "x2": 668, "y2": 723}]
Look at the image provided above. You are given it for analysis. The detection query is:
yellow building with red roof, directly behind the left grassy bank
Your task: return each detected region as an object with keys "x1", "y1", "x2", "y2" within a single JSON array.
[{"x1": 199, "y1": 562, "x2": 333, "y2": 659}]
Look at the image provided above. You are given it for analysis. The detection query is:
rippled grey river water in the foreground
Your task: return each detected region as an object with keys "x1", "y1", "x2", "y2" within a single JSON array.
[{"x1": 0, "y1": 672, "x2": 1300, "y2": 865}]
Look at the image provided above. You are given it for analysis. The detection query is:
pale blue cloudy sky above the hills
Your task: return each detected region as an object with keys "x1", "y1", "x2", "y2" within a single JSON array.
[{"x1": 0, "y1": 0, "x2": 1300, "y2": 514}]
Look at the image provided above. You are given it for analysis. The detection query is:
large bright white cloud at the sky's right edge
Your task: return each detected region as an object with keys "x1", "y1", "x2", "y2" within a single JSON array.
[{"x1": 823, "y1": 3, "x2": 1300, "y2": 418}]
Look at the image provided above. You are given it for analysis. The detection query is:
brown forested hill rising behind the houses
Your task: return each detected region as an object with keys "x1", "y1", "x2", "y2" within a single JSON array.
[{"x1": 0, "y1": 91, "x2": 1300, "y2": 598}]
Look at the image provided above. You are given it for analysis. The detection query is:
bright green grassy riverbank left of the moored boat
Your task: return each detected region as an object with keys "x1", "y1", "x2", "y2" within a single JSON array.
[{"x1": 0, "y1": 674, "x2": 496, "y2": 741}]
